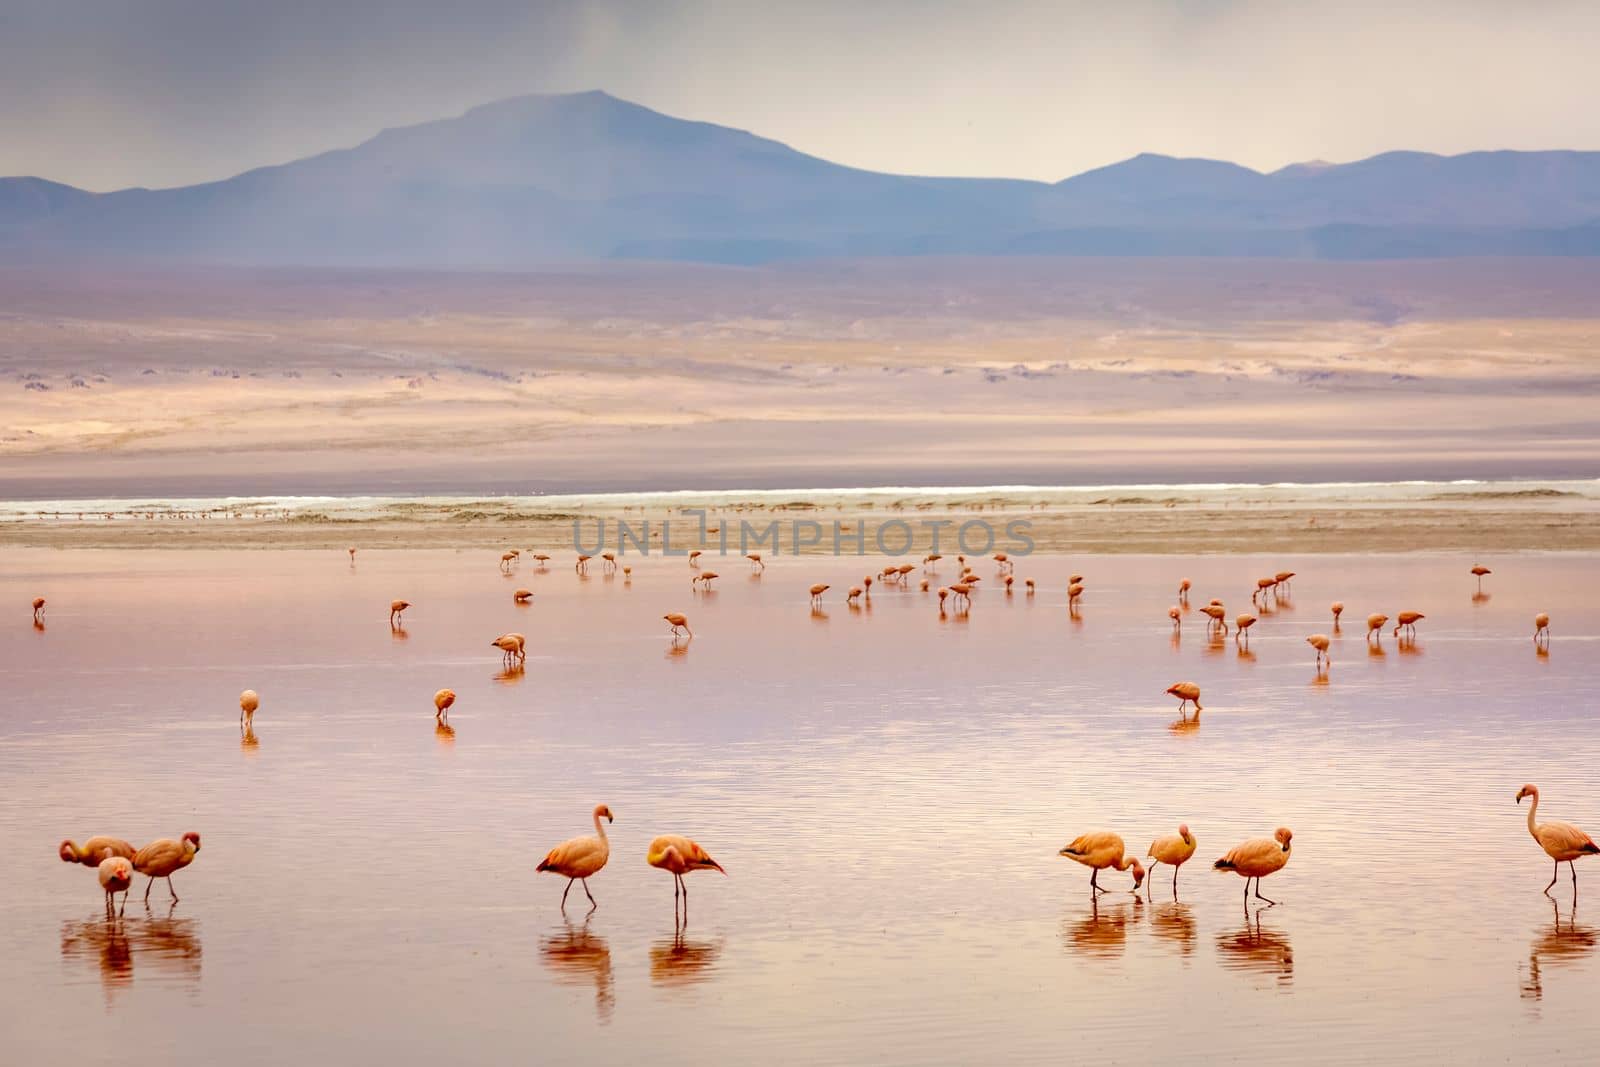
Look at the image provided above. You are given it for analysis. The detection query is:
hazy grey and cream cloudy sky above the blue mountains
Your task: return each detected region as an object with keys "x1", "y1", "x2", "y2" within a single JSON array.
[{"x1": 0, "y1": 0, "x2": 1600, "y2": 189}]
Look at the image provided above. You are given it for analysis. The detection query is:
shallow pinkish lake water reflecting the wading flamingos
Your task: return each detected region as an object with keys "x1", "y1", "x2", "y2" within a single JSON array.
[{"x1": 0, "y1": 550, "x2": 1600, "y2": 1064}]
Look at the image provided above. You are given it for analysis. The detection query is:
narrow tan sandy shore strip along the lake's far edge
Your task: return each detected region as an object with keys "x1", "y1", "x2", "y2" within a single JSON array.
[{"x1": 0, "y1": 491, "x2": 1600, "y2": 556}]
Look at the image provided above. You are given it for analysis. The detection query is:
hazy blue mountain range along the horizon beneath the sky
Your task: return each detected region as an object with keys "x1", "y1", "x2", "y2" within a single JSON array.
[{"x1": 0, "y1": 93, "x2": 1600, "y2": 267}]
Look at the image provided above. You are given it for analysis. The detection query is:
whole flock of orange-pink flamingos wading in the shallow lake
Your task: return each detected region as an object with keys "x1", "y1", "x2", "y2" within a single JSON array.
[{"x1": 32, "y1": 547, "x2": 1600, "y2": 913}]
